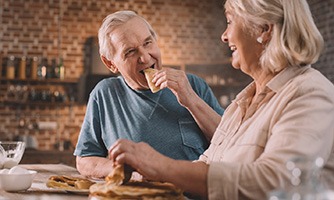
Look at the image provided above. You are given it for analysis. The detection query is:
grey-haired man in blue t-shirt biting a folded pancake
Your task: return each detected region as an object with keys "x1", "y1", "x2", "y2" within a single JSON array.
[{"x1": 74, "y1": 11, "x2": 224, "y2": 178}]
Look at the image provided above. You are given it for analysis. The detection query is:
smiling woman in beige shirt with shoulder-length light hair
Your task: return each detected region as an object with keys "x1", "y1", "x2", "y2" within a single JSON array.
[{"x1": 109, "y1": 0, "x2": 334, "y2": 199}]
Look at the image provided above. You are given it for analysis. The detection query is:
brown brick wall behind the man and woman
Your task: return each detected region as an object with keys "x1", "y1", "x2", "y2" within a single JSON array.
[{"x1": 0, "y1": 0, "x2": 334, "y2": 150}]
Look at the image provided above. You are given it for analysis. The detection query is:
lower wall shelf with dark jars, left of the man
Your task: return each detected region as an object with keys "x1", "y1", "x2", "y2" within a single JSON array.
[{"x1": 0, "y1": 77, "x2": 79, "y2": 107}]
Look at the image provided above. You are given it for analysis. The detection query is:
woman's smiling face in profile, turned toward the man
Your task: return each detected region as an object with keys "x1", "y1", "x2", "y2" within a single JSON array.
[{"x1": 221, "y1": 12, "x2": 263, "y2": 77}]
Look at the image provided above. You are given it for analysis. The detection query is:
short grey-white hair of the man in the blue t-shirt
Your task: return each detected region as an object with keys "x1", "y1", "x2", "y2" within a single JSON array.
[{"x1": 98, "y1": 10, "x2": 157, "y2": 60}]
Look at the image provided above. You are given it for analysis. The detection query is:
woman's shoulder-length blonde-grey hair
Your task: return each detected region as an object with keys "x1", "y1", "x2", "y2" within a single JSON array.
[{"x1": 225, "y1": 0, "x2": 324, "y2": 73}]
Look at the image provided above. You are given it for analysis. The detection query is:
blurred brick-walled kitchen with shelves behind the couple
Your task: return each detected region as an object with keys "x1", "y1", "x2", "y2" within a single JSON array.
[{"x1": 0, "y1": 0, "x2": 334, "y2": 165}]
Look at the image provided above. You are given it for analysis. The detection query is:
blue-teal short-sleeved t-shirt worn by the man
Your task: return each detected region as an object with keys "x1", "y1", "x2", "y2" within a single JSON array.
[{"x1": 74, "y1": 74, "x2": 224, "y2": 160}]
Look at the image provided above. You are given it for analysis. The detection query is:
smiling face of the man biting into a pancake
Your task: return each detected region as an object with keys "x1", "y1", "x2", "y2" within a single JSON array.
[{"x1": 110, "y1": 17, "x2": 162, "y2": 90}]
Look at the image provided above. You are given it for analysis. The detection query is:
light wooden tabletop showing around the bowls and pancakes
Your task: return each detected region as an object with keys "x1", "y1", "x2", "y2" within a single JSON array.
[{"x1": 0, "y1": 164, "x2": 93, "y2": 200}]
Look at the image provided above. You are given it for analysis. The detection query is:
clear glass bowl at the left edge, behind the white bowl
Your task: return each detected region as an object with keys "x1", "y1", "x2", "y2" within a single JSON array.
[{"x1": 0, "y1": 141, "x2": 25, "y2": 169}]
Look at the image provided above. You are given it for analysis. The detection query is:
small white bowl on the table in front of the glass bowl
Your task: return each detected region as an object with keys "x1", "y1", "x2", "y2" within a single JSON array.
[{"x1": 0, "y1": 170, "x2": 37, "y2": 192}]
